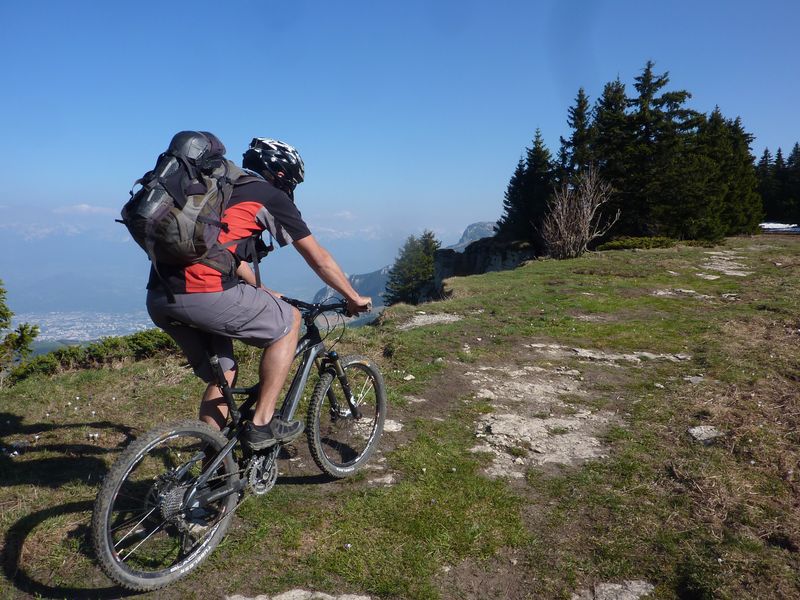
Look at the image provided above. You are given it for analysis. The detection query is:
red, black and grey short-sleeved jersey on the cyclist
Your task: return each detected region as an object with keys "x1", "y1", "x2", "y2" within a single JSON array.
[{"x1": 147, "y1": 181, "x2": 311, "y2": 294}]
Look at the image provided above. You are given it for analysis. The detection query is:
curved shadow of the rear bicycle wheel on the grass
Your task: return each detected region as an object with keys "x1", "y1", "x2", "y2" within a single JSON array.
[{"x1": 2, "y1": 501, "x2": 133, "y2": 600}]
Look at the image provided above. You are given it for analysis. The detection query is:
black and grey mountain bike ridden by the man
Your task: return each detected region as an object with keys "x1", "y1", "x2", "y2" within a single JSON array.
[{"x1": 92, "y1": 298, "x2": 386, "y2": 591}]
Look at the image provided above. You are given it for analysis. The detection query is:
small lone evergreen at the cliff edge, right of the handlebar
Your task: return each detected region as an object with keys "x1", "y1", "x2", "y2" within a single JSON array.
[{"x1": 385, "y1": 230, "x2": 441, "y2": 306}]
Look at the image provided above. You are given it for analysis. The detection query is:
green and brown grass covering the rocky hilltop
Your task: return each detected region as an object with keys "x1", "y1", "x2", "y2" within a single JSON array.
[{"x1": 0, "y1": 236, "x2": 800, "y2": 598}]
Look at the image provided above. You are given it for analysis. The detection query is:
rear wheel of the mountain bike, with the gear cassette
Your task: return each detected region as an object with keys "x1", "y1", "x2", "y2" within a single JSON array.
[{"x1": 92, "y1": 421, "x2": 238, "y2": 591}]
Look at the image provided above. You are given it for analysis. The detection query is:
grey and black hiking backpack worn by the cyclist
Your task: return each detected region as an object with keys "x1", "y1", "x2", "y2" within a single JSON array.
[{"x1": 117, "y1": 131, "x2": 266, "y2": 302}]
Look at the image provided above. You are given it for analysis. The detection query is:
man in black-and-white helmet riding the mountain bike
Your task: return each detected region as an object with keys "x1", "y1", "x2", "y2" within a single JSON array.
[{"x1": 147, "y1": 138, "x2": 371, "y2": 450}]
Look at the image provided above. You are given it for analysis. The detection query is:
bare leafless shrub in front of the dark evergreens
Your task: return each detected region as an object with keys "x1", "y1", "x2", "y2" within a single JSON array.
[{"x1": 542, "y1": 167, "x2": 620, "y2": 258}]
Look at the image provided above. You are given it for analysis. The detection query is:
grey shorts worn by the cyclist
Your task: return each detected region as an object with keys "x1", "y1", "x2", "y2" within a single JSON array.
[{"x1": 147, "y1": 283, "x2": 294, "y2": 382}]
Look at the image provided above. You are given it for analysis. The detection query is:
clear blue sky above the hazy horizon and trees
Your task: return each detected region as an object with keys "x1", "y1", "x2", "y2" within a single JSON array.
[{"x1": 0, "y1": 0, "x2": 800, "y2": 311}]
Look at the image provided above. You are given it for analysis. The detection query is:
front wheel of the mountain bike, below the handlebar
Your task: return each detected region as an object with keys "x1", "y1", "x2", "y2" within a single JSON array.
[{"x1": 306, "y1": 356, "x2": 386, "y2": 478}]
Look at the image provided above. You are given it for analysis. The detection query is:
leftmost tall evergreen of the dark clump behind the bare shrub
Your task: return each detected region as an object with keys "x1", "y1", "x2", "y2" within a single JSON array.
[{"x1": 496, "y1": 129, "x2": 553, "y2": 252}]
